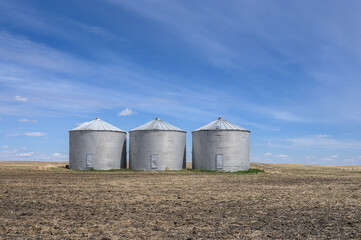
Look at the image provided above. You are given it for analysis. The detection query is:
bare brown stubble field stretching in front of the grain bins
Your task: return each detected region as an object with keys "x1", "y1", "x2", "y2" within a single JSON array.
[{"x1": 0, "y1": 162, "x2": 361, "y2": 239}]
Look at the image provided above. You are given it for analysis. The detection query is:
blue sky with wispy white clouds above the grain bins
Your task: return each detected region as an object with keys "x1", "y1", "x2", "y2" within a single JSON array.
[{"x1": 0, "y1": 0, "x2": 361, "y2": 165}]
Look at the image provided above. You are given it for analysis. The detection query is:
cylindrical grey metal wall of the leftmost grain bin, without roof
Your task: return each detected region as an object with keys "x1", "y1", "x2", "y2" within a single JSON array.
[{"x1": 69, "y1": 130, "x2": 126, "y2": 170}]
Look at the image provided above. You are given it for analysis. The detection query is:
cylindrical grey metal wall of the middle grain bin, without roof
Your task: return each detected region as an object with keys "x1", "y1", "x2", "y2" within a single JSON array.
[{"x1": 129, "y1": 130, "x2": 186, "y2": 170}]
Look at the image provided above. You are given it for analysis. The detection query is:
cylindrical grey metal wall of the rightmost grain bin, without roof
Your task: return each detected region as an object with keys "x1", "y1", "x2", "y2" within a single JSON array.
[{"x1": 192, "y1": 130, "x2": 250, "y2": 172}]
